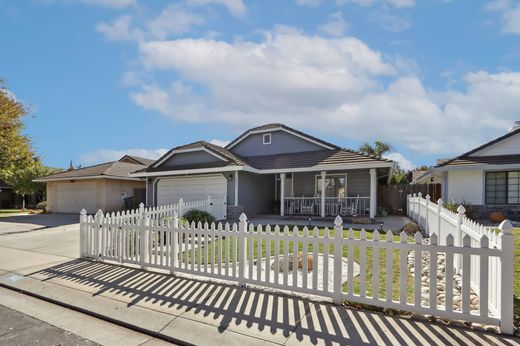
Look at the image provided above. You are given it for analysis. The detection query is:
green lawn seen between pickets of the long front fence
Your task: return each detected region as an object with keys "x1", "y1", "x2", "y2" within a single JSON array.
[{"x1": 179, "y1": 229, "x2": 413, "y2": 302}]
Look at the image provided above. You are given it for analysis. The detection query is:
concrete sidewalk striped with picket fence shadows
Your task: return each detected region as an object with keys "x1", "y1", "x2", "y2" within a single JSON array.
[{"x1": 0, "y1": 253, "x2": 520, "y2": 346}]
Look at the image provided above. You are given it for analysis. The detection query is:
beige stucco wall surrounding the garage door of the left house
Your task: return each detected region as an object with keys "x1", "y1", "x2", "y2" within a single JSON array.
[{"x1": 47, "y1": 179, "x2": 146, "y2": 212}]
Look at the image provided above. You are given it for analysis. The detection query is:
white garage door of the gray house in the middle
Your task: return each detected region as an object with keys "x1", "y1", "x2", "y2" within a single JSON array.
[{"x1": 157, "y1": 174, "x2": 227, "y2": 205}]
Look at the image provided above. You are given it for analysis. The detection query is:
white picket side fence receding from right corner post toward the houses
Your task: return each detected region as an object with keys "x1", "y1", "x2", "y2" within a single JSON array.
[{"x1": 407, "y1": 193, "x2": 514, "y2": 334}]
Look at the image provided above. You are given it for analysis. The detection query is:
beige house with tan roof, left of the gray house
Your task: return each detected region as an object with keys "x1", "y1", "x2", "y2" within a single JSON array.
[{"x1": 34, "y1": 155, "x2": 154, "y2": 213}]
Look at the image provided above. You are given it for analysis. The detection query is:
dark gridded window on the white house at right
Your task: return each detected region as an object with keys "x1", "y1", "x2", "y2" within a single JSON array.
[{"x1": 486, "y1": 171, "x2": 520, "y2": 204}]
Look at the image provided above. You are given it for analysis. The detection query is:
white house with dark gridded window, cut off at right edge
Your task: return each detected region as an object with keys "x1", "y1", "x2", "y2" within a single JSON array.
[{"x1": 433, "y1": 123, "x2": 520, "y2": 219}]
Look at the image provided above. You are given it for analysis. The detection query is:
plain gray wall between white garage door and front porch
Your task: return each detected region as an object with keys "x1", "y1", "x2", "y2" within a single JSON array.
[{"x1": 238, "y1": 172, "x2": 274, "y2": 217}]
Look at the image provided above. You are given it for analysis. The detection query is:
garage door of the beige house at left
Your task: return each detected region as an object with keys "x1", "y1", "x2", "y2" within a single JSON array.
[{"x1": 55, "y1": 181, "x2": 98, "y2": 213}]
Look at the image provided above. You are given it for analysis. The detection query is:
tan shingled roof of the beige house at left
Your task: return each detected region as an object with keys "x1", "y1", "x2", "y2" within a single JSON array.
[{"x1": 34, "y1": 155, "x2": 153, "y2": 182}]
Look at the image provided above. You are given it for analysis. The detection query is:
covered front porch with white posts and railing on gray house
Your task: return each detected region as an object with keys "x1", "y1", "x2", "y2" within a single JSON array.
[{"x1": 275, "y1": 168, "x2": 377, "y2": 219}]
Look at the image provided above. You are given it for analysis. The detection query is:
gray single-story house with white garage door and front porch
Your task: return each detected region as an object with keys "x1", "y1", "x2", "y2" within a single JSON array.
[{"x1": 131, "y1": 124, "x2": 394, "y2": 219}]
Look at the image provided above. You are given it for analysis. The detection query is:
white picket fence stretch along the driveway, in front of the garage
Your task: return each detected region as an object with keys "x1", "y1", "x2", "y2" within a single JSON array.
[{"x1": 106, "y1": 196, "x2": 226, "y2": 225}]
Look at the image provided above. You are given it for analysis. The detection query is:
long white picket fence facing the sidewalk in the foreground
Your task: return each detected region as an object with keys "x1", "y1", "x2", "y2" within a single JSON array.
[{"x1": 80, "y1": 204, "x2": 513, "y2": 333}]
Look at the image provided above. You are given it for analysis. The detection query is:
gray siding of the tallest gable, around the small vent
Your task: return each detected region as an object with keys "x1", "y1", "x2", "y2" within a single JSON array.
[{"x1": 231, "y1": 131, "x2": 324, "y2": 156}]
